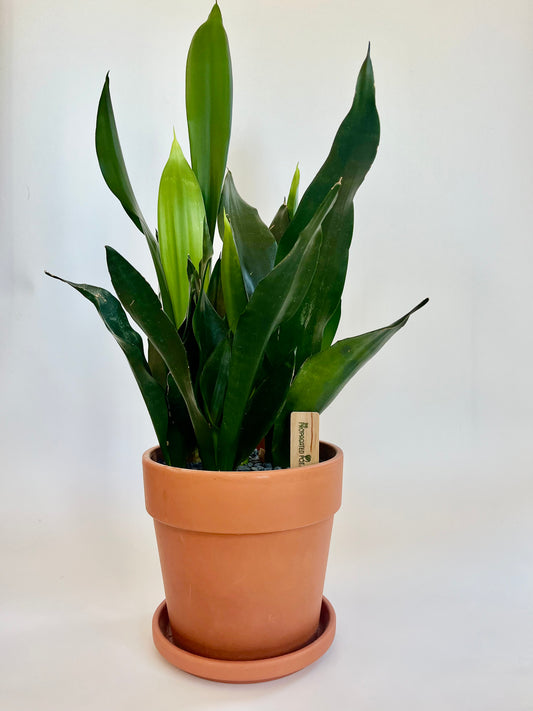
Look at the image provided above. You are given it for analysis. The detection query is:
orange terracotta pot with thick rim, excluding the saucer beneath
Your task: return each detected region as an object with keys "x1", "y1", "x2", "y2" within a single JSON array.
[{"x1": 143, "y1": 443, "x2": 342, "y2": 660}]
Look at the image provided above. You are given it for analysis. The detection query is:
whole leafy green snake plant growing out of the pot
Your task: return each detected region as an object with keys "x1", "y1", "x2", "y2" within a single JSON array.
[{"x1": 46, "y1": 4, "x2": 427, "y2": 470}]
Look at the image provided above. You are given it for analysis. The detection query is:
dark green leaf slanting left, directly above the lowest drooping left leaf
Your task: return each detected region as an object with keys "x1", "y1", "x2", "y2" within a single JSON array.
[{"x1": 106, "y1": 247, "x2": 215, "y2": 469}]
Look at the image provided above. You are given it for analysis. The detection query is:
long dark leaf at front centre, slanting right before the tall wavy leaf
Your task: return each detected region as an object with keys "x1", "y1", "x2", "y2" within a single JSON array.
[{"x1": 214, "y1": 185, "x2": 339, "y2": 469}]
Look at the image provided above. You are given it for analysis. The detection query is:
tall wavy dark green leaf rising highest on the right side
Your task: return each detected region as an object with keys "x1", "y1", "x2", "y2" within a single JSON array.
[{"x1": 276, "y1": 54, "x2": 379, "y2": 367}]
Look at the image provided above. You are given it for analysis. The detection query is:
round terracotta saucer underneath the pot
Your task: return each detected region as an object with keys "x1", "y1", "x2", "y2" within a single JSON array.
[{"x1": 152, "y1": 597, "x2": 335, "y2": 684}]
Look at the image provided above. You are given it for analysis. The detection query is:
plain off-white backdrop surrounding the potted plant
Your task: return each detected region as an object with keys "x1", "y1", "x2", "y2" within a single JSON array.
[{"x1": 0, "y1": 0, "x2": 533, "y2": 711}]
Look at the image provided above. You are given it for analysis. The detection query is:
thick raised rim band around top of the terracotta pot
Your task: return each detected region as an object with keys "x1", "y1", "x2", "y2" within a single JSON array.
[{"x1": 142, "y1": 442, "x2": 343, "y2": 534}]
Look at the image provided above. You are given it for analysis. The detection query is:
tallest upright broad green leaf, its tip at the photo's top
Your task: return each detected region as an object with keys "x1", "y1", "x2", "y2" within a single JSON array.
[{"x1": 186, "y1": 4, "x2": 233, "y2": 239}]
